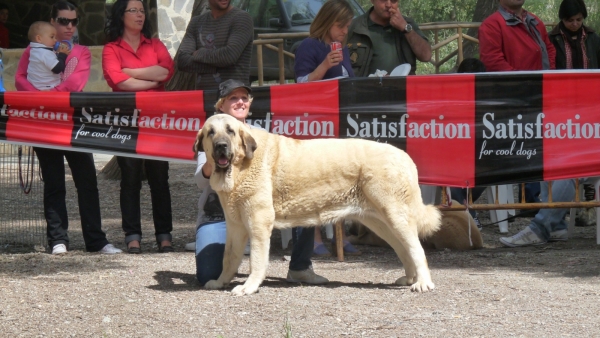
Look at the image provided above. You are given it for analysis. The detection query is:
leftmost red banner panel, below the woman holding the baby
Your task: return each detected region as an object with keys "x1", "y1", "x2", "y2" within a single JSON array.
[{"x1": 4, "y1": 92, "x2": 73, "y2": 146}]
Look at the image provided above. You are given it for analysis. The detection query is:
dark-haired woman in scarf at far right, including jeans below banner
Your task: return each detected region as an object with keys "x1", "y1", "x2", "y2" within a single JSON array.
[{"x1": 500, "y1": 0, "x2": 600, "y2": 247}]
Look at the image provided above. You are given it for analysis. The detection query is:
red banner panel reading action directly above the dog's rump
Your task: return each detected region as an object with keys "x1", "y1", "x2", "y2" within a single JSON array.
[{"x1": 406, "y1": 75, "x2": 475, "y2": 187}]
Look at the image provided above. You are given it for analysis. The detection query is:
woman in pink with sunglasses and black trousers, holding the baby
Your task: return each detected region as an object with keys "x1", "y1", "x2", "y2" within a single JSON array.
[{"x1": 15, "y1": 1, "x2": 122, "y2": 254}]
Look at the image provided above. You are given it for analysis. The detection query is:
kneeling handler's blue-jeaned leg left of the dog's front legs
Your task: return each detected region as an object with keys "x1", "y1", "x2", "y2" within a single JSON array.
[{"x1": 196, "y1": 222, "x2": 227, "y2": 285}]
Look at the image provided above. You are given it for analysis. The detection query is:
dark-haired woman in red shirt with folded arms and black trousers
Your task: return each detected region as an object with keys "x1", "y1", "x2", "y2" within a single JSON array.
[{"x1": 102, "y1": 0, "x2": 174, "y2": 254}]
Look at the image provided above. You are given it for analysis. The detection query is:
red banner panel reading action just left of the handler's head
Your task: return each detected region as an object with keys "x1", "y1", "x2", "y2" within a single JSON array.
[{"x1": 135, "y1": 91, "x2": 206, "y2": 160}]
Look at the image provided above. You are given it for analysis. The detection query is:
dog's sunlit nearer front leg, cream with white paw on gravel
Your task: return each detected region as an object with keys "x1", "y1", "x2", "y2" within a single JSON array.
[{"x1": 231, "y1": 210, "x2": 275, "y2": 296}]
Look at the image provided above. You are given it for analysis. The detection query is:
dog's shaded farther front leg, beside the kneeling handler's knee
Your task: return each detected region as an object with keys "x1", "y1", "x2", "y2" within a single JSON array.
[{"x1": 204, "y1": 222, "x2": 248, "y2": 290}]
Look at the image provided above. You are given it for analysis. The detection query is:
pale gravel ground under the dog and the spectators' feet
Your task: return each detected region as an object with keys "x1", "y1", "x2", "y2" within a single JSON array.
[{"x1": 0, "y1": 157, "x2": 600, "y2": 337}]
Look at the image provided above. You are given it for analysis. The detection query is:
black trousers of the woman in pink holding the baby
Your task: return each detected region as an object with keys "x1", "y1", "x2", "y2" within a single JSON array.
[{"x1": 33, "y1": 147, "x2": 108, "y2": 251}]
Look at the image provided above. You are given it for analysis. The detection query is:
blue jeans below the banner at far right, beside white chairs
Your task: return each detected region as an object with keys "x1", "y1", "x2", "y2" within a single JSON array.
[{"x1": 529, "y1": 180, "x2": 575, "y2": 241}]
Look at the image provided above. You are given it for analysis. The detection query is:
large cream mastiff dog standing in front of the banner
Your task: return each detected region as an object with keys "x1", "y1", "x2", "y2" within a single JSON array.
[{"x1": 194, "y1": 114, "x2": 440, "y2": 295}]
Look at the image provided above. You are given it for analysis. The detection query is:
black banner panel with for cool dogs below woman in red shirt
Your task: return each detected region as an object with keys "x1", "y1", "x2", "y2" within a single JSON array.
[{"x1": 71, "y1": 93, "x2": 138, "y2": 153}]
